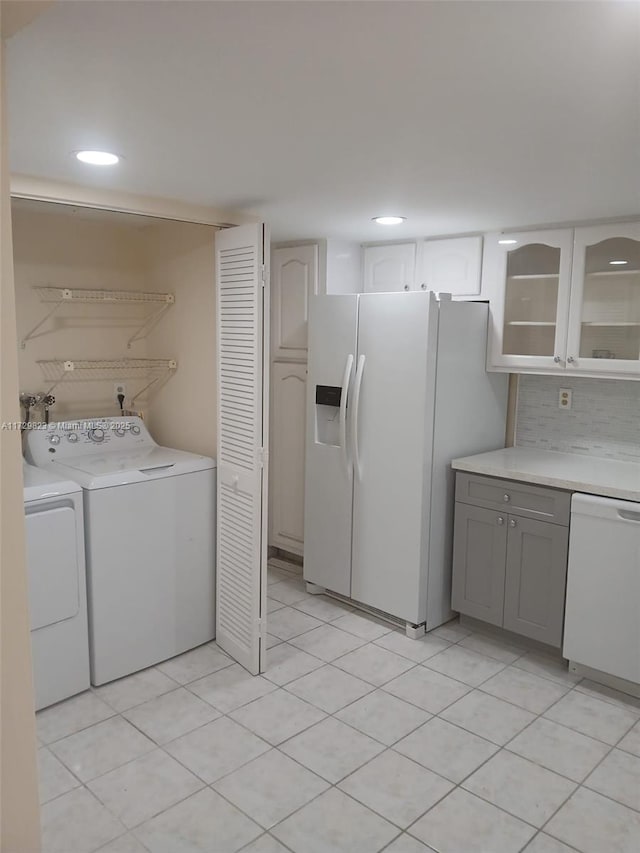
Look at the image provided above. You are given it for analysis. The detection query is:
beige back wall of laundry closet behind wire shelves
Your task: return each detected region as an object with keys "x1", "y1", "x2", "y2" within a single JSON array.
[{"x1": 12, "y1": 202, "x2": 152, "y2": 420}]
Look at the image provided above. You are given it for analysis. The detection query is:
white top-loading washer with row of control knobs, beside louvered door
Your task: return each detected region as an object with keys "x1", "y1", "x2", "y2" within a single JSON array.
[{"x1": 25, "y1": 417, "x2": 216, "y2": 685}]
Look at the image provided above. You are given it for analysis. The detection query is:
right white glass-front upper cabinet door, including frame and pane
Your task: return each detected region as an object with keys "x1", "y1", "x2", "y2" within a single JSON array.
[{"x1": 567, "y1": 222, "x2": 640, "y2": 377}]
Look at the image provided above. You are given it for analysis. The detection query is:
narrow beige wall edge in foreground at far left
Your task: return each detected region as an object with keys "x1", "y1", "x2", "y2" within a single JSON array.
[{"x1": 0, "y1": 23, "x2": 40, "y2": 853}]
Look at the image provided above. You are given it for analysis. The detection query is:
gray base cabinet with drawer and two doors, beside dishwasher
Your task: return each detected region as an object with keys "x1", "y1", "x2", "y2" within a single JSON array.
[{"x1": 451, "y1": 473, "x2": 571, "y2": 647}]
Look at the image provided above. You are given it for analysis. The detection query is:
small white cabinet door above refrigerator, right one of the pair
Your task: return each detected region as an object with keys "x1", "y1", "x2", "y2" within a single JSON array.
[{"x1": 418, "y1": 235, "x2": 482, "y2": 299}]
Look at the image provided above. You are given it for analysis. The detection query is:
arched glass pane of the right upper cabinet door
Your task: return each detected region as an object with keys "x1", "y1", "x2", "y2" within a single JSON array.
[{"x1": 580, "y1": 237, "x2": 640, "y2": 361}]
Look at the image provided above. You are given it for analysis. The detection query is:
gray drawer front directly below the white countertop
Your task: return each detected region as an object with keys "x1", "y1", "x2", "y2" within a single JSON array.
[{"x1": 456, "y1": 471, "x2": 571, "y2": 526}]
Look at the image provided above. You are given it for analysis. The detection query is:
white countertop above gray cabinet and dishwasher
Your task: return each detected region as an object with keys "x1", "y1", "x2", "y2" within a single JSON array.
[{"x1": 451, "y1": 447, "x2": 640, "y2": 501}]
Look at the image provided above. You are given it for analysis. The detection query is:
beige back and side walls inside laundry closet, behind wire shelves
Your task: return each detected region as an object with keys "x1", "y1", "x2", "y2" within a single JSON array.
[{"x1": 13, "y1": 201, "x2": 216, "y2": 455}]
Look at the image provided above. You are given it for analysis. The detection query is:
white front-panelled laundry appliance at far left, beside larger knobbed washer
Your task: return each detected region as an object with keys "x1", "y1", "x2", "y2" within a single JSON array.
[{"x1": 23, "y1": 462, "x2": 89, "y2": 710}]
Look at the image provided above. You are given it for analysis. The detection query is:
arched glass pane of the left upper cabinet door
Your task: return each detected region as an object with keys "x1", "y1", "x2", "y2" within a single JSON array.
[{"x1": 502, "y1": 243, "x2": 560, "y2": 356}]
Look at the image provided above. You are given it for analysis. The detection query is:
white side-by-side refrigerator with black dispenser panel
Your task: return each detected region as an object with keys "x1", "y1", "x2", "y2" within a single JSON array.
[{"x1": 304, "y1": 291, "x2": 508, "y2": 635}]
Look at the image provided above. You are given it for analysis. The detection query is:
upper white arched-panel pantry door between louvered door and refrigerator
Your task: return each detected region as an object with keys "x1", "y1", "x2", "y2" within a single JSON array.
[{"x1": 271, "y1": 244, "x2": 318, "y2": 361}]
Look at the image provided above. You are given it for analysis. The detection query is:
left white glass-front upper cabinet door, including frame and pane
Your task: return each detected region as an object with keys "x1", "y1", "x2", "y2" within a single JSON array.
[{"x1": 483, "y1": 229, "x2": 573, "y2": 372}]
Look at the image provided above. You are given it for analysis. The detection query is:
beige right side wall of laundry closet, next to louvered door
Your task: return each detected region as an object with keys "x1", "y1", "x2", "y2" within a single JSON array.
[{"x1": 146, "y1": 222, "x2": 217, "y2": 456}]
